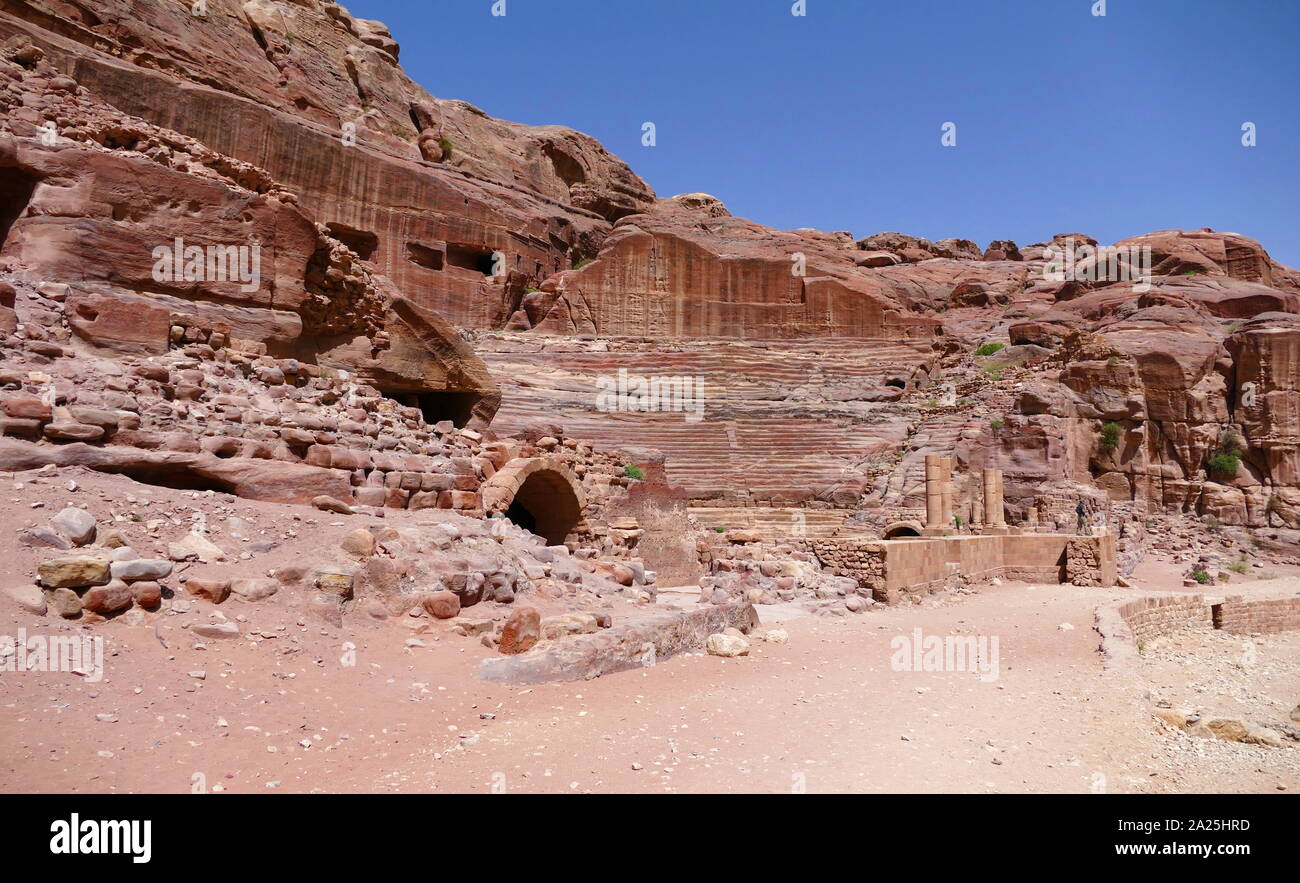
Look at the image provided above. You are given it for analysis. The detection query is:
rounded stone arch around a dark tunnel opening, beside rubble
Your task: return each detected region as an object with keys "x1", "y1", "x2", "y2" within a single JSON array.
[{"x1": 482, "y1": 456, "x2": 586, "y2": 546}]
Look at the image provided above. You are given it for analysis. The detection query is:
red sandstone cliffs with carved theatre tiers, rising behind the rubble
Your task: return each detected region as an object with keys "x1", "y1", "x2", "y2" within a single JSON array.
[{"x1": 0, "y1": 0, "x2": 1300, "y2": 556}]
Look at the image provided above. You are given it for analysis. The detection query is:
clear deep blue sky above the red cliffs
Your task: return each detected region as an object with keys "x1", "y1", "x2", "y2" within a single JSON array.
[{"x1": 346, "y1": 0, "x2": 1300, "y2": 267}]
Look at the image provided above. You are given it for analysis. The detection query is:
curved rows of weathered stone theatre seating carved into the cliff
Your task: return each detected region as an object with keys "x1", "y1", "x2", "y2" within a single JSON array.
[{"x1": 475, "y1": 333, "x2": 935, "y2": 506}]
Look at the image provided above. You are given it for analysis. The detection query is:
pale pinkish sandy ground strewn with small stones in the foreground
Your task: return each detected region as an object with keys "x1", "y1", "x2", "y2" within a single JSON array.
[{"x1": 0, "y1": 470, "x2": 1300, "y2": 793}]
